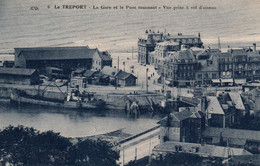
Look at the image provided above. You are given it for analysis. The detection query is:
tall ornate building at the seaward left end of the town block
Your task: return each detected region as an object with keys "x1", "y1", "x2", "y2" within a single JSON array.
[{"x1": 137, "y1": 30, "x2": 163, "y2": 64}]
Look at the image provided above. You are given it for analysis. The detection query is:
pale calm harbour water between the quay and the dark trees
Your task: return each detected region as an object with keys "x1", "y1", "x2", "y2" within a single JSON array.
[{"x1": 0, "y1": 102, "x2": 159, "y2": 137}]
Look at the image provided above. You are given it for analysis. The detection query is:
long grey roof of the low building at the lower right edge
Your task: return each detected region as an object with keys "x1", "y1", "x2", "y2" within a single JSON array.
[{"x1": 203, "y1": 127, "x2": 260, "y2": 141}]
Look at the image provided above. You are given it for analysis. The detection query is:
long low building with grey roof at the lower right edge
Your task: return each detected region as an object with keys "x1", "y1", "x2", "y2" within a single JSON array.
[{"x1": 202, "y1": 127, "x2": 260, "y2": 153}]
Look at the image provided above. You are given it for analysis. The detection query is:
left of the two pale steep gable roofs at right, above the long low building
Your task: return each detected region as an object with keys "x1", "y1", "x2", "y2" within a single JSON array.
[{"x1": 206, "y1": 96, "x2": 225, "y2": 115}]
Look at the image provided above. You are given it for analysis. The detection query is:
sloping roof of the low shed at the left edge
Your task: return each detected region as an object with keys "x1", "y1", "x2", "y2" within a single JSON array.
[{"x1": 0, "y1": 67, "x2": 36, "y2": 76}]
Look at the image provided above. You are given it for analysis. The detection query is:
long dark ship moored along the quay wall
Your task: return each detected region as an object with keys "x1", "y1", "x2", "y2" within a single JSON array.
[{"x1": 10, "y1": 89, "x2": 105, "y2": 110}]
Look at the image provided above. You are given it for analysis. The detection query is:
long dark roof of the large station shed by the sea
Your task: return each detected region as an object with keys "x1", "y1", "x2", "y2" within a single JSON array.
[{"x1": 15, "y1": 46, "x2": 98, "y2": 60}]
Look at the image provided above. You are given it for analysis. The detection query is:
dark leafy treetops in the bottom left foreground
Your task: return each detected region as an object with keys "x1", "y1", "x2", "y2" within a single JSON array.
[{"x1": 0, "y1": 126, "x2": 119, "y2": 166}]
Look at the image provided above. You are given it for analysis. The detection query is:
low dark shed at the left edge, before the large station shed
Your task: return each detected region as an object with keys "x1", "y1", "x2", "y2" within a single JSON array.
[{"x1": 0, "y1": 67, "x2": 40, "y2": 85}]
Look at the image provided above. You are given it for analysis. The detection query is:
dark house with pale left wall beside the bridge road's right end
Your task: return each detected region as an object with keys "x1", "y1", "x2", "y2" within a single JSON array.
[{"x1": 159, "y1": 107, "x2": 205, "y2": 143}]
